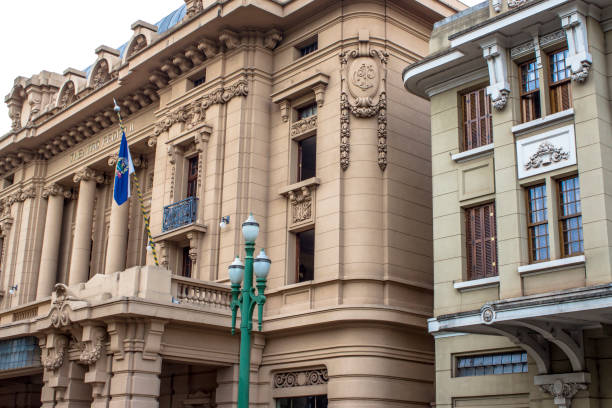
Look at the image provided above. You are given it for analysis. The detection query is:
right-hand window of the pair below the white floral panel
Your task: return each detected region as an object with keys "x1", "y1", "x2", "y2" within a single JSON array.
[{"x1": 558, "y1": 176, "x2": 584, "y2": 257}]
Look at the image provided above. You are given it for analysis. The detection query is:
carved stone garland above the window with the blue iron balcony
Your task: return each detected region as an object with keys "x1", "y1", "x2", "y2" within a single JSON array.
[{"x1": 153, "y1": 79, "x2": 249, "y2": 136}]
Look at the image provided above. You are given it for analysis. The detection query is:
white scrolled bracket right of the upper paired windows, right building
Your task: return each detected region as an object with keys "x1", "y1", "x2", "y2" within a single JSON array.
[{"x1": 560, "y1": 9, "x2": 593, "y2": 82}]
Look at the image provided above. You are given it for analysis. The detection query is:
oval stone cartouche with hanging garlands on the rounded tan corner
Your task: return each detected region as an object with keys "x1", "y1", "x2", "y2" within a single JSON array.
[{"x1": 340, "y1": 33, "x2": 389, "y2": 171}]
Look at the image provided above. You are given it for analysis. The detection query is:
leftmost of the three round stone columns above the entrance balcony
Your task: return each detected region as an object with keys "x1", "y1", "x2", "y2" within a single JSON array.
[{"x1": 36, "y1": 183, "x2": 70, "y2": 299}]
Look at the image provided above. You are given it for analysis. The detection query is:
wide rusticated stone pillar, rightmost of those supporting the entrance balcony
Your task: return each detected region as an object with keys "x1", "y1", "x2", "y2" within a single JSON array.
[{"x1": 108, "y1": 319, "x2": 165, "y2": 408}]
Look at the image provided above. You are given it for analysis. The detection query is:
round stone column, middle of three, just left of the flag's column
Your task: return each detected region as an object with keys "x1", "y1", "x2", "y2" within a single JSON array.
[{"x1": 68, "y1": 167, "x2": 103, "y2": 285}]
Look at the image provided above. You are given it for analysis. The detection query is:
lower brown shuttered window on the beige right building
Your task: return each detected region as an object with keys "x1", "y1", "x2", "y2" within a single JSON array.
[{"x1": 465, "y1": 203, "x2": 497, "y2": 280}]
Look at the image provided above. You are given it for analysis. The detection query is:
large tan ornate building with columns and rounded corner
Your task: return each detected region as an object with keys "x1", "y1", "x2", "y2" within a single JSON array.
[{"x1": 0, "y1": 0, "x2": 463, "y2": 408}]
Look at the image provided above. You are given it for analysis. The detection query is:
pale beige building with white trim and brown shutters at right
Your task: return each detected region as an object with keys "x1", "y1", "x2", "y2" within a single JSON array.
[{"x1": 403, "y1": 0, "x2": 612, "y2": 407}]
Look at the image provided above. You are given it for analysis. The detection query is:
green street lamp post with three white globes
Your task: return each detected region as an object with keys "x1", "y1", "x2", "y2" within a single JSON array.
[{"x1": 229, "y1": 214, "x2": 271, "y2": 408}]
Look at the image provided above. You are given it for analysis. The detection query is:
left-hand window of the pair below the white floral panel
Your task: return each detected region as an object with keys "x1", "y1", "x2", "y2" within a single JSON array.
[{"x1": 527, "y1": 184, "x2": 550, "y2": 262}]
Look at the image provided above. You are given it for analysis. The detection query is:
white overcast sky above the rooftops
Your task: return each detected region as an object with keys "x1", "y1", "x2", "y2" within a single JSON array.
[{"x1": 0, "y1": 0, "x2": 482, "y2": 135}]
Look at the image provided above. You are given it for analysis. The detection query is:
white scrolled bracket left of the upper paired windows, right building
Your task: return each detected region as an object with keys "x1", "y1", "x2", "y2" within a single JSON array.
[{"x1": 482, "y1": 39, "x2": 510, "y2": 110}]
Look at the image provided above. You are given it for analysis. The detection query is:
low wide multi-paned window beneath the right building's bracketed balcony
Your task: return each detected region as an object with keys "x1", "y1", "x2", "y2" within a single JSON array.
[{"x1": 455, "y1": 351, "x2": 529, "y2": 377}]
